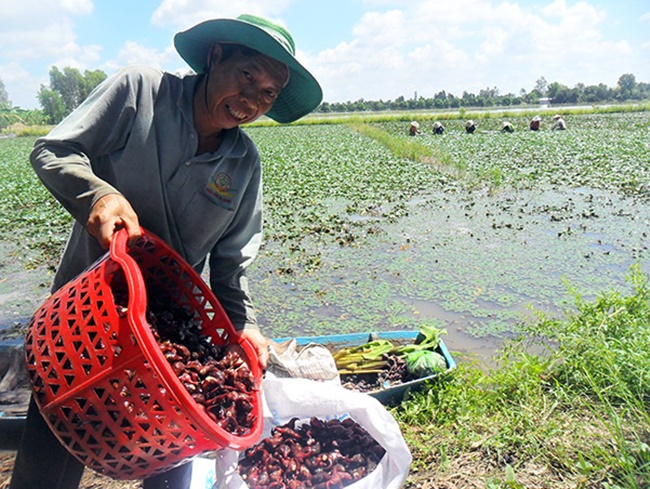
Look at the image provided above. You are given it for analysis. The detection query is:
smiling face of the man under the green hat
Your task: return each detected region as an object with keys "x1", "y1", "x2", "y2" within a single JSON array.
[{"x1": 204, "y1": 45, "x2": 288, "y2": 130}]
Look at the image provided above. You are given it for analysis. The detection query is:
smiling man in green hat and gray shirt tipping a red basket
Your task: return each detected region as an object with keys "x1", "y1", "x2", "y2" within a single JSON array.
[{"x1": 10, "y1": 15, "x2": 322, "y2": 489}]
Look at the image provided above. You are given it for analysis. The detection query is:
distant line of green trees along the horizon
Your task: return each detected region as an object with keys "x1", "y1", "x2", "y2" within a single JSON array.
[{"x1": 0, "y1": 66, "x2": 650, "y2": 129}]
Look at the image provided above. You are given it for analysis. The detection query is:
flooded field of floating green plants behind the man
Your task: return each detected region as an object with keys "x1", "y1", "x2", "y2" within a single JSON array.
[{"x1": 0, "y1": 112, "x2": 650, "y2": 366}]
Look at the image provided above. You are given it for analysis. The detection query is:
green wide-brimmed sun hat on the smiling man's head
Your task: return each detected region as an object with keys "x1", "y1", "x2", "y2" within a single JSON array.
[{"x1": 174, "y1": 15, "x2": 323, "y2": 123}]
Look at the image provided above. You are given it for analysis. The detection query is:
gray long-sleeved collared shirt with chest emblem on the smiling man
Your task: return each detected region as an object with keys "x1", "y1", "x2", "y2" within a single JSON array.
[{"x1": 31, "y1": 67, "x2": 262, "y2": 329}]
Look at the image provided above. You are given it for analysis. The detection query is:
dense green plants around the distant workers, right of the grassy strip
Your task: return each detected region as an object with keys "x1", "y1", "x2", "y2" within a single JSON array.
[{"x1": 375, "y1": 107, "x2": 650, "y2": 194}]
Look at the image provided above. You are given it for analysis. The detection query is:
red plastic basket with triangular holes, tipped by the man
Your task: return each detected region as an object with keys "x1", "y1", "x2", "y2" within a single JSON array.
[{"x1": 25, "y1": 230, "x2": 262, "y2": 479}]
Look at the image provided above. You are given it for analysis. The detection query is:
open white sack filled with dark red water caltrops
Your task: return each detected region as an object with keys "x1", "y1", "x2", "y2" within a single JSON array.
[{"x1": 214, "y1": 372, "x2": 411, "y2": 489}]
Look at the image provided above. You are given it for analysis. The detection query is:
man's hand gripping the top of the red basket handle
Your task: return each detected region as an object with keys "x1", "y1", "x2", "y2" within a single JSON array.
[{"x1": 86, "y1": 194, "x2": 142, "y2": 249}]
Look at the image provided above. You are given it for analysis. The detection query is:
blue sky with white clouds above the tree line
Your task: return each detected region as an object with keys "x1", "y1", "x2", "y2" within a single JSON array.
[{"x1": 0, "y1": 0, "x2": 650, "y2": 109}]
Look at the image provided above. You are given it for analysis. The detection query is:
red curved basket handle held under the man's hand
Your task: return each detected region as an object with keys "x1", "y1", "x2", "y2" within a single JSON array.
[{"x1": 110, "y1": 228, "x2": 147, "y2": 324}]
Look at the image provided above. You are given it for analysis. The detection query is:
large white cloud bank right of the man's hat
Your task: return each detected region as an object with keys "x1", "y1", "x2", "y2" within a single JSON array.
[{"x1": 309, "y1": 0, "x2": 650, "y2": 101}]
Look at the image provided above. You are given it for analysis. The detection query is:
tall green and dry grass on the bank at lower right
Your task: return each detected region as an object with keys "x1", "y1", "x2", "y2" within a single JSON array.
[{"x1": 393, "y1": 269, "x2": 650, "y2": 489}]
